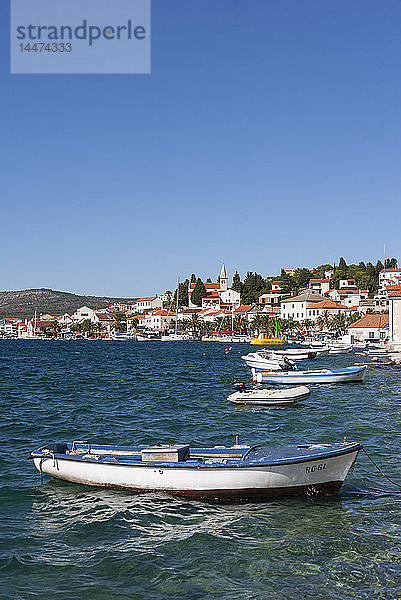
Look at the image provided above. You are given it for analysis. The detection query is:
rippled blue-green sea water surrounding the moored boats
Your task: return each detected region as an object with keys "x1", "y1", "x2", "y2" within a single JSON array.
[{"x1": 0, "y1": 340, "x2": 401, "y2": 600}]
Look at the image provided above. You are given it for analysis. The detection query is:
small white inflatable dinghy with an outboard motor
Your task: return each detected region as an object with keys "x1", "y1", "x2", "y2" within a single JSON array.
[{"x1": 227, "y1": 383, "x2": 310, "y2": 407}]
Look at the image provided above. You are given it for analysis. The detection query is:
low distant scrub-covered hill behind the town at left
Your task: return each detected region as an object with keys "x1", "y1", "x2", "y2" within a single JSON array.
[{"x1": 0, "y1": 288, "x2": 132, "y2": 319}]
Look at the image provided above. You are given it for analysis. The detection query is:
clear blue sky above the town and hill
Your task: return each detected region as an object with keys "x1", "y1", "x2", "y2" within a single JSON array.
[{"x1": 0, "y1": 0, "x2": 401, "y2": 296}]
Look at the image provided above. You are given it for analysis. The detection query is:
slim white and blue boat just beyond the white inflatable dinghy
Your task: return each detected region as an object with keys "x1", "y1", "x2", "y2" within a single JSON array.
[{"x1": 252, "y1": 365, "x2": 367, "y2": 384}]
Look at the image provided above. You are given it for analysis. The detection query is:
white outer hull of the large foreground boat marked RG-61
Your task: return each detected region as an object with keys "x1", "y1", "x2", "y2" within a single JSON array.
[{"x1": 33, "y1": 444, "x2": 361, "y2": 500}]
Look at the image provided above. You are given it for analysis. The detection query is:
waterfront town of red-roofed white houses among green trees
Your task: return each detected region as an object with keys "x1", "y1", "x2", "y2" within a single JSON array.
[{"x1": 0, "y1": 258, "x2": 401, "y2": 349}]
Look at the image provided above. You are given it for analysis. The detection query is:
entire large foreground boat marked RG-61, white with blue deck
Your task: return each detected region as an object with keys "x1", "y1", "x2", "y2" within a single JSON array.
[{"x1": 30, "y1": 441, "x2": 362, "y2": 500}]
